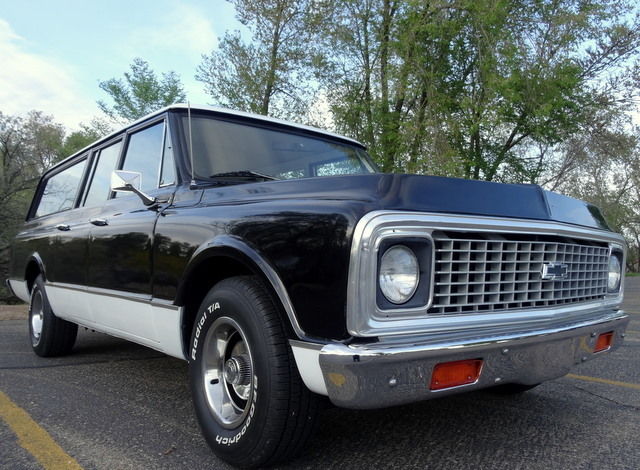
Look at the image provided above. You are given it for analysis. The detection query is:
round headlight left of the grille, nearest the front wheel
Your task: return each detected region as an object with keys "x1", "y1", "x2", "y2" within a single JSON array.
[{"x1": 378, "y1": 245, "x2": 420, "y2": 304}]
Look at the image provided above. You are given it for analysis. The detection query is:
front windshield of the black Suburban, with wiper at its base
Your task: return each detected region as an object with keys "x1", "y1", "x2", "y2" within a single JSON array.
[{"x1": 183, "y1": 116, "x2": 375, "y2": 179}]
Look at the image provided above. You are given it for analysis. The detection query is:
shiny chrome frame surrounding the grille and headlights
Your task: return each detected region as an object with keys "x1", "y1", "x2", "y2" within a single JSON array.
[{"x1": 347, "y1": 211, "x2": 626, "y2": 337}]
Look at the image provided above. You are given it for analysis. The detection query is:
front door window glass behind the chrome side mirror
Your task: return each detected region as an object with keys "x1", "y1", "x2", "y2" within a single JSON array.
[{"x1": 122, "y1": 122, "x2": 164, "y2": 192}]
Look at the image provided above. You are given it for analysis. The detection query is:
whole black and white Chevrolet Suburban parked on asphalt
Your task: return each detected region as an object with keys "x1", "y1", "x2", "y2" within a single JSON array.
[{"x1": 3, "y1": 105, "x2": 628, "y2": 467}]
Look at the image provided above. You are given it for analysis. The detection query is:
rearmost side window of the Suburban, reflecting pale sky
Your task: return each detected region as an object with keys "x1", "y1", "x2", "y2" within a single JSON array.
[{"x1": 36, "y1": 159, "x2": 87, "y2": 217}]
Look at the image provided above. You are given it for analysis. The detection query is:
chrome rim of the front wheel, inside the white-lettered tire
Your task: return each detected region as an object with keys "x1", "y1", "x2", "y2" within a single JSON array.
[{"x1": 202, "y1": 317, "x2": 255, "y2": 429}]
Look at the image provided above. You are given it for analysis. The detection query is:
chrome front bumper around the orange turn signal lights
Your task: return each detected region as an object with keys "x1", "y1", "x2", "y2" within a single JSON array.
[{"x1": 312, "y1": 310, "x2": 629, "y2": 409}]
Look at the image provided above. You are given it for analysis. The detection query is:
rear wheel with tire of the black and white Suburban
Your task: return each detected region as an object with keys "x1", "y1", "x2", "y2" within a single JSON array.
[{"x1": 29, "y1": 275, "x2": 78, "y2": 357}]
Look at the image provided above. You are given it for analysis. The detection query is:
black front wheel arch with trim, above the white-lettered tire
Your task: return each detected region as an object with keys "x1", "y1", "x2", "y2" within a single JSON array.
[{"x1": 175, "y1": 235, "x2": 306, "y2": 357}]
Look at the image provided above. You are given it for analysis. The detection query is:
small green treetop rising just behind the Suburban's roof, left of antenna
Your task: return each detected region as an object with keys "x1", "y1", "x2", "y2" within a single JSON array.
[{"x1": 98, "y1": 58, "x2": 186, "y2": 123}]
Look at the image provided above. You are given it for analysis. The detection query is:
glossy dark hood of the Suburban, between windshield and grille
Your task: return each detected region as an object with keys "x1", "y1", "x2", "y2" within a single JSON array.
[{"x1": 203, "y1": 174, "x2": 609, "y2": 230}]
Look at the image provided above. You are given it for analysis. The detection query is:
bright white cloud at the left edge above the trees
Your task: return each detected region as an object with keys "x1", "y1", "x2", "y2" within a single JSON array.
[{"x1": 0, "y1": 18, "x2": 97, "y2": 128}]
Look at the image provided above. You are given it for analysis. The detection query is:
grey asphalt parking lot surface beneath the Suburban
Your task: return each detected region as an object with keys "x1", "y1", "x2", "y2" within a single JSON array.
[{"x1": 0, "y1": 277, "x2": 640, "y2": 470}]
